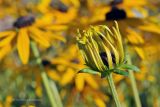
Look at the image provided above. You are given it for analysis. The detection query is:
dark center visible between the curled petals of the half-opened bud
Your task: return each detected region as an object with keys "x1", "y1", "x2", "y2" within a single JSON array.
[{"x1": 100, "y1": 52, "x2": 116, "y2": 67}]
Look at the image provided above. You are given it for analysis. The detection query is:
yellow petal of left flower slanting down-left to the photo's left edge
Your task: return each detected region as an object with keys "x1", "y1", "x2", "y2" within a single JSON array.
[{"x1": 0, "y1": 32, "x2": 16, "y2": 47}]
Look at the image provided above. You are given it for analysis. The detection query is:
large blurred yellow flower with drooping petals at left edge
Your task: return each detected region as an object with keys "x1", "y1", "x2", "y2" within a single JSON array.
[{"x1": 0, "y1": 16, "x2": 64, "y2": 64}]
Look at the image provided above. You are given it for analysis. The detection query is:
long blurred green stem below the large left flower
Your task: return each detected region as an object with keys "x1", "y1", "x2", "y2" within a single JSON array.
[{"x1": 31, "y1": 41, "x2": 62, "y2": 107}]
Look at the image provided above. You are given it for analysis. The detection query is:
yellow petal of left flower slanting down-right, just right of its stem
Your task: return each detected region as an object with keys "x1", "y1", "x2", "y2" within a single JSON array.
[{"x1": 29, "y1": 27, "x2": 50, "y2": 48}]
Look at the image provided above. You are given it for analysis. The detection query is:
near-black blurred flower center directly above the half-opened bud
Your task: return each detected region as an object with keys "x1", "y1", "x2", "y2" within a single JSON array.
[{"x1": 106, "y1": 7, "x2": 127, "y2": 21}]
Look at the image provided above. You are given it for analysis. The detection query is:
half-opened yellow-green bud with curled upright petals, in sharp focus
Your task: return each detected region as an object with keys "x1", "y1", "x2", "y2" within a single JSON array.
[{"x1": 77, "y1": 22, "x2": 138, "y2": 76}]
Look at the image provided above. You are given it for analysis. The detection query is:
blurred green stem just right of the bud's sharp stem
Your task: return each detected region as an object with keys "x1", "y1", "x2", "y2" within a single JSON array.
[{"x1": 127, "y1": 55, "x2": 141, "y2": 107}]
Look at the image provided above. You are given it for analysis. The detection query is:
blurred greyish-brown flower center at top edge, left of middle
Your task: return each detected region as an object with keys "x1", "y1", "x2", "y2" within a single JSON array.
[{"x1": 50, "y1": 0, "x2": 68, "y2": 13}]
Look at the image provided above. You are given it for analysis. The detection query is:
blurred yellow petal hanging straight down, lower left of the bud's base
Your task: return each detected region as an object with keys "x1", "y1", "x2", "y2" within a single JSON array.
[{"x1": 75, "y1": 73, "x2": 85, "y2": 91}]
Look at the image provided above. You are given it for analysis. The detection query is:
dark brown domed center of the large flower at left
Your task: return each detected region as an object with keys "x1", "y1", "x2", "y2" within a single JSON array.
[{"x1": 13, "y1": 16, "x2": 35, "y2": 28}]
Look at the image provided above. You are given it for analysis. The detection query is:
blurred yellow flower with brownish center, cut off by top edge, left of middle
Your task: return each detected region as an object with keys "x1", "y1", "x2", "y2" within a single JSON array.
[{"x1": 37, "y1": 0, "x2": 79, "y2": 24}]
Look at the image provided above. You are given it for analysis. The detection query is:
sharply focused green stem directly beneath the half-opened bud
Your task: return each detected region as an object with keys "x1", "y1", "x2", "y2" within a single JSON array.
[{"x1": 107, "y1": 73, "x2": 121, "y2": 107}]
